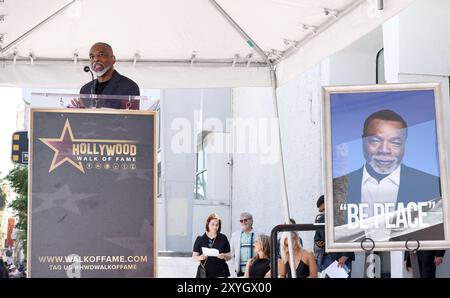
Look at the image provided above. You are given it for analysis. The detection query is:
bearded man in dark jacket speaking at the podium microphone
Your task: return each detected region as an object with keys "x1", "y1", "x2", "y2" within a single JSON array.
[{"x1": 72, "y1": 42, "x2": 140, "y2": 109}]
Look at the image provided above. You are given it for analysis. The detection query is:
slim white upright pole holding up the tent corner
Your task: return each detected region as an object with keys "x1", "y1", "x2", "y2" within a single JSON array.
[{"x1": 270, "y1": 64, "x2": 297, "y2": 278}]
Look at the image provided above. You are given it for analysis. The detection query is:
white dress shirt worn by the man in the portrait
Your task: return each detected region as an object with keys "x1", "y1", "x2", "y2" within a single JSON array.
[{"x1": 361, "y1": 166, "x2": 401, "y2": 241}]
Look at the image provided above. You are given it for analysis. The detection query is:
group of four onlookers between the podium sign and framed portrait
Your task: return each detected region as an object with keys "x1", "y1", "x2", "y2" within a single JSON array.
[{"x1": 192, "y1": 208, "x2": 328, "y2": 278}]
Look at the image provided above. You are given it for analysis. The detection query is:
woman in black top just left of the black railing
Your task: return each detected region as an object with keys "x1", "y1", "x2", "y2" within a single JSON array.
[{"x1": 244, "y1": 235, "x2": 270, "y2": 278}]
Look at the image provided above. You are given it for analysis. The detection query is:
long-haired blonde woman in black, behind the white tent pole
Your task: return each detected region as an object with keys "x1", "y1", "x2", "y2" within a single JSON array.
[{"x1": 278, "y1": 232, "x2": 317, "y2": 278}]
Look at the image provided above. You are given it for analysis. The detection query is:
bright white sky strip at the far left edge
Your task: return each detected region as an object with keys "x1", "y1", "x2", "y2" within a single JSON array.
[{"x1": 0, "y1": 87, "x2": 23, "y2": 178}]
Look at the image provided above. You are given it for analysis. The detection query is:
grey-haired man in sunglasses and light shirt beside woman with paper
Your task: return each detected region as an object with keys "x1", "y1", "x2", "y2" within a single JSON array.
[{"x1": 230, "y1": 212, "x2": 259, "y2": 277}]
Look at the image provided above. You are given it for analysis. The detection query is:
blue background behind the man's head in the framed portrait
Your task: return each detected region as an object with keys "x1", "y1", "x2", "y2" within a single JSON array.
[{"x1": 331, "y1": 90, "x2": 440, "y2": 178}]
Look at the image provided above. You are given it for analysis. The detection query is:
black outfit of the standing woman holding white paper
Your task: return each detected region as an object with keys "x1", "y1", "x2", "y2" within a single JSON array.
[{"x1": 193, "y1": 233, "x2": 231, "y2": 278}]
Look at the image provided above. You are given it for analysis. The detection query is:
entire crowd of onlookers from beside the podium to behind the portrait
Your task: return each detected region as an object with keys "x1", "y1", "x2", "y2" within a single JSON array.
[{"x1": 192, "y1": 196, "x2": 445, "y2": 278}]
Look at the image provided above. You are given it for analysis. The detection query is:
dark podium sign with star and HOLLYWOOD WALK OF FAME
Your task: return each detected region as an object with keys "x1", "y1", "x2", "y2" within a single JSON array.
[{"x1": 28, "y1": 108, "x2": 157, "y2": 277}]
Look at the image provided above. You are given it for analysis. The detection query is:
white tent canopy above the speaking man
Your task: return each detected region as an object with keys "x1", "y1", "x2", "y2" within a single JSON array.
[{"x1": 0, "y1": 0, "x2": 414, "y2": 88}]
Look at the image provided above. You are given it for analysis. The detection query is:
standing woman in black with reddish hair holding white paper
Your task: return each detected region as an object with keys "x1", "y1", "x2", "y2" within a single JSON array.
[{"x1": 192, "y1": 213, "x2": 231, "y2": 278}]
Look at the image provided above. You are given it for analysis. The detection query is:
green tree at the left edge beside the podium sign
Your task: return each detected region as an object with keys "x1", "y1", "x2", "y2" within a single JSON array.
[{"x1": 5, "y1": 165, "x2": 28, "y2": 254}]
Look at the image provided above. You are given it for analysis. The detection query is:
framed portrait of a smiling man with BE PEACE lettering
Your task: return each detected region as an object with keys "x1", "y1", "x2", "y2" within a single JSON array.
[{"x1": 323, "y1": 83, "x2": 450, "y2": 252}]
